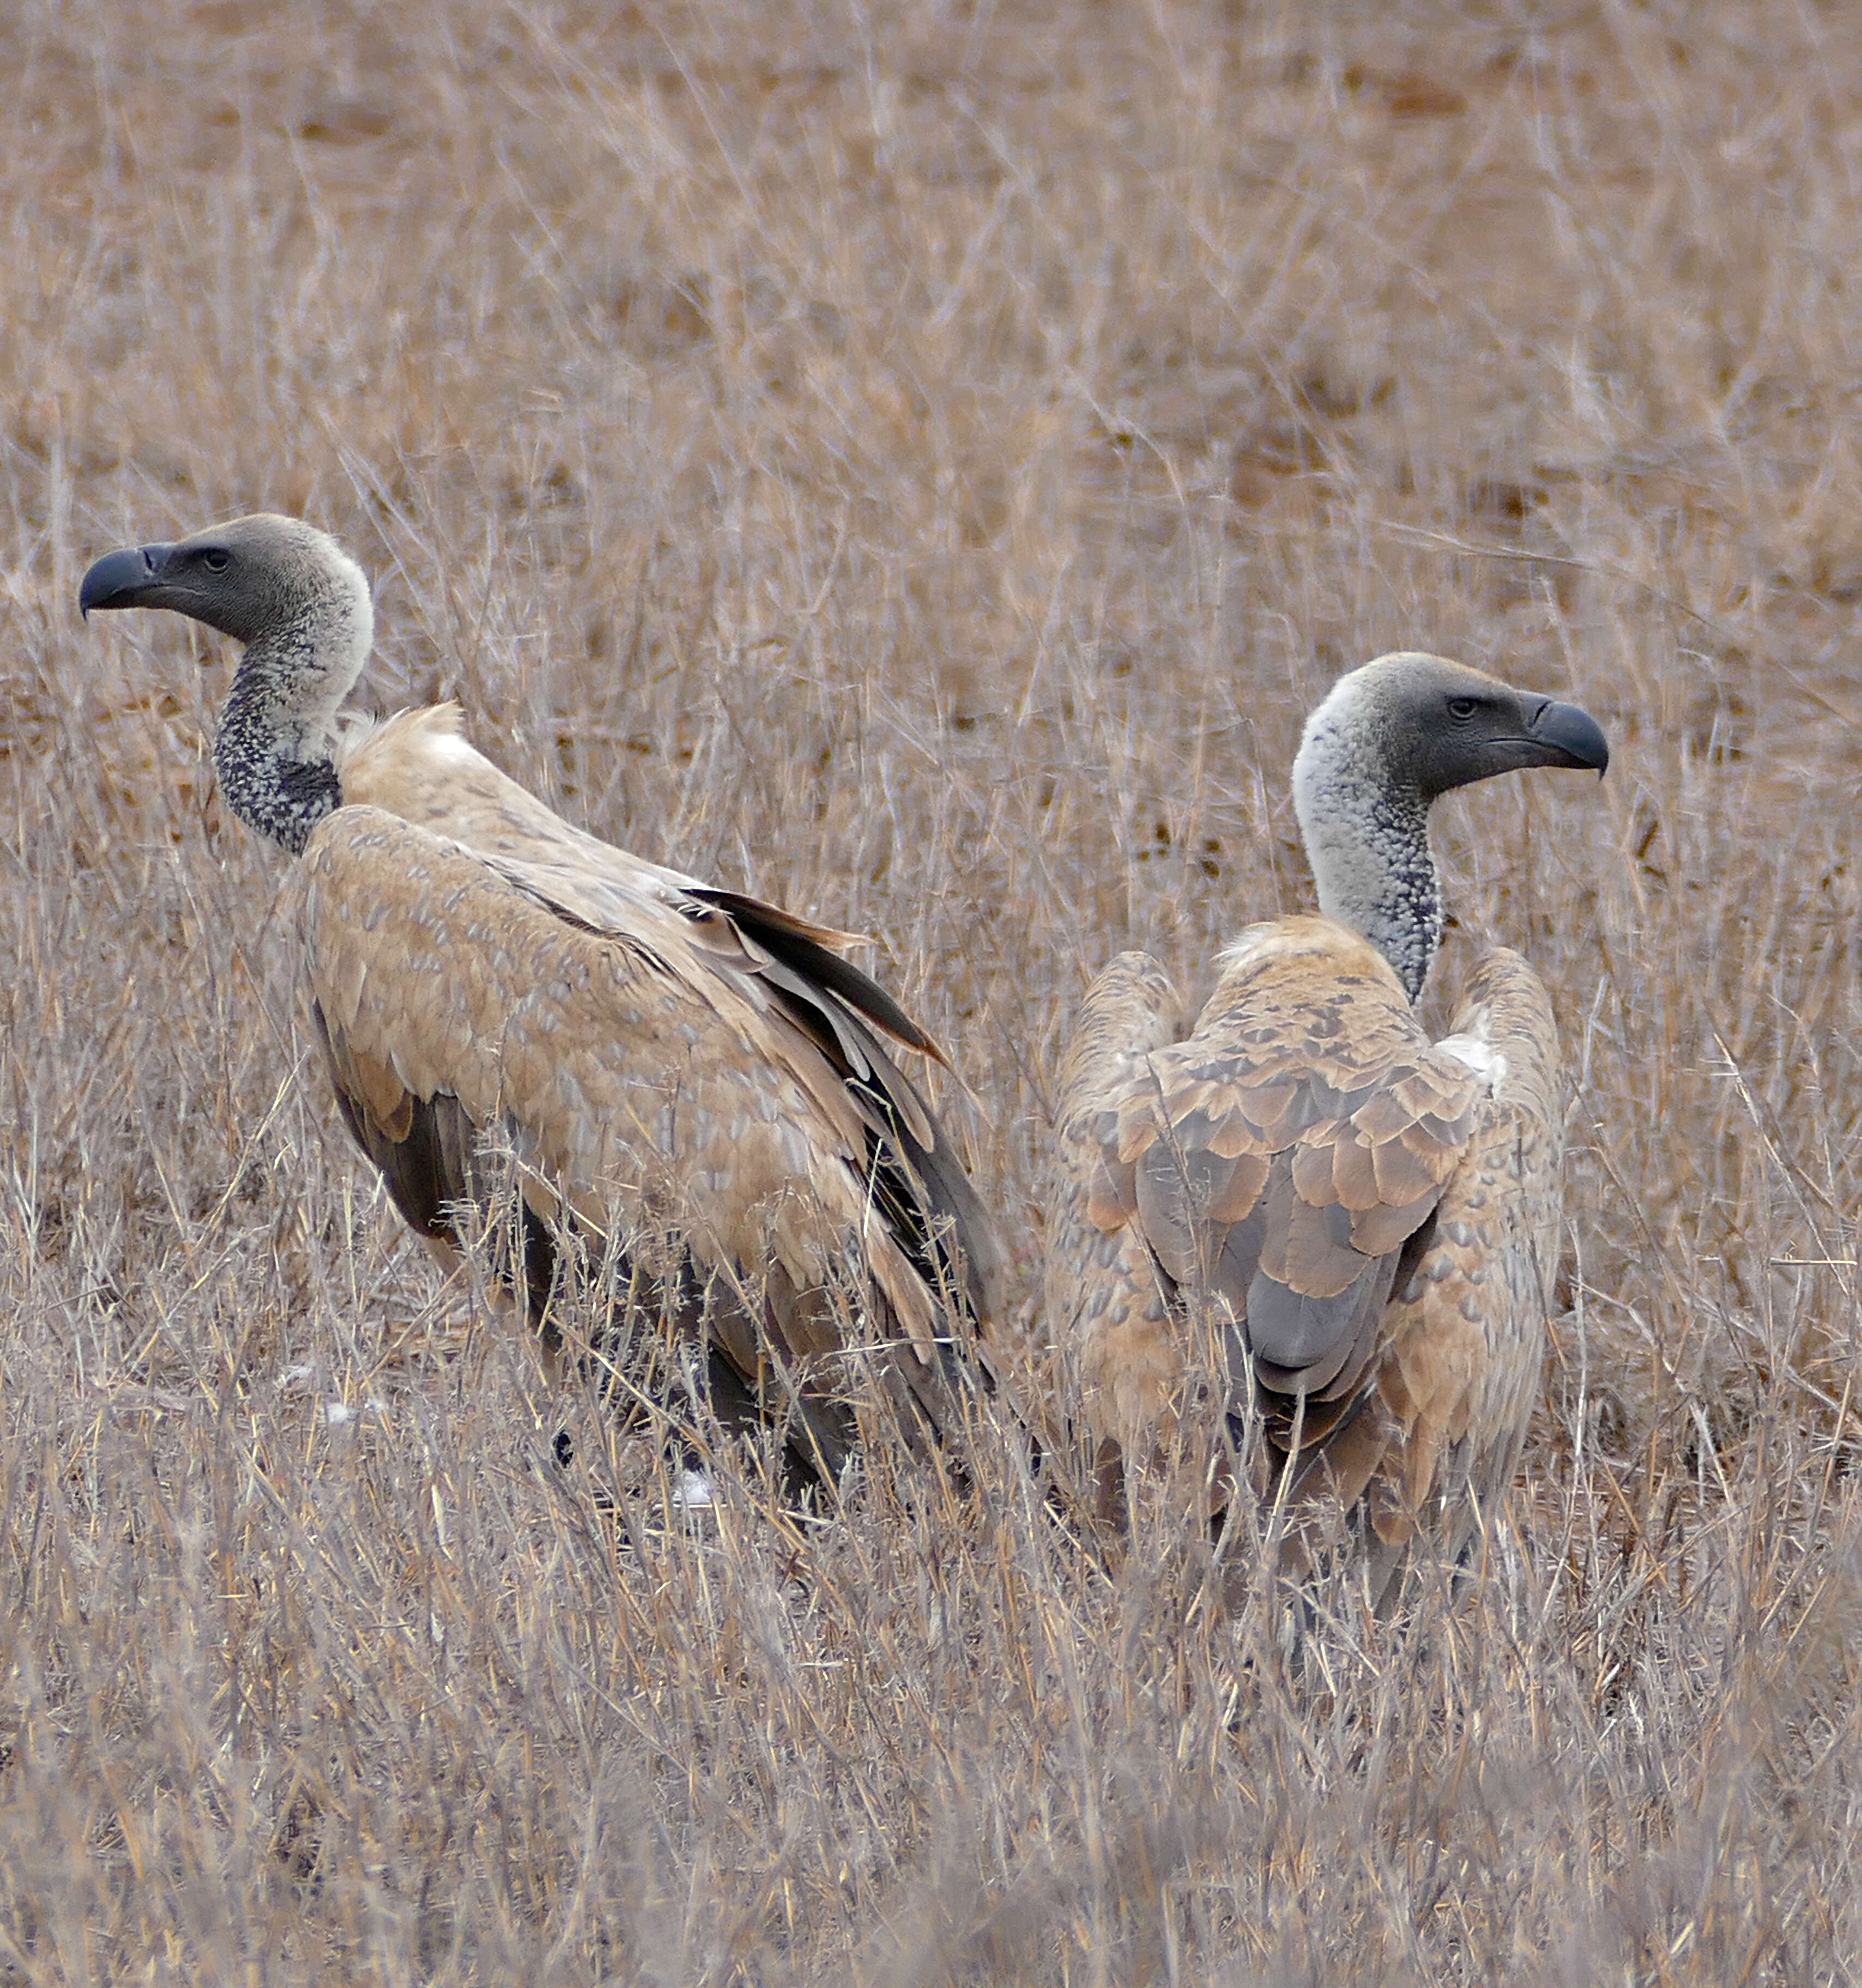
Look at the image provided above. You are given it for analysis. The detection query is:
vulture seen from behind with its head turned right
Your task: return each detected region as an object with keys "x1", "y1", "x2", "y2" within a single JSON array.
[{"x1": 1047, "y1": 654, "x2": 1610, "y2": 1607}]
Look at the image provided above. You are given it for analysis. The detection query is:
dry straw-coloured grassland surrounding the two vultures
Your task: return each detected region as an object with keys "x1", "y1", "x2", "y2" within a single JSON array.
[{"x1": 0, "y1": 0, "x2": 1862, "y2": 1984}]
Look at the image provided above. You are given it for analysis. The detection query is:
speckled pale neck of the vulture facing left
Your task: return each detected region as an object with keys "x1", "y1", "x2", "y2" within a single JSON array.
[{"x1": 213, "y1": 561, "x2": 374, "y2": 855}]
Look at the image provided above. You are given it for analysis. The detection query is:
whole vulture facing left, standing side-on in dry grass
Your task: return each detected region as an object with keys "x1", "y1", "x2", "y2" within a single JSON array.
[{"x1": 80, "y1": 515, "x2": 1001, "y2": 1475}]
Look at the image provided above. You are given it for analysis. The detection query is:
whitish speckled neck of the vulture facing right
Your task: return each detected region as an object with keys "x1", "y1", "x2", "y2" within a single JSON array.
[{"x1": 1293, "y1": 698, "x2": 1442, "y2": 1002}]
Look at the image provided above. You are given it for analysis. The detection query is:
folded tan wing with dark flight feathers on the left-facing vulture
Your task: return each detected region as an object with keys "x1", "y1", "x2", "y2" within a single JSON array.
[{"x1": 303, "y1": 789, "x2": 996, "y2": 1467}]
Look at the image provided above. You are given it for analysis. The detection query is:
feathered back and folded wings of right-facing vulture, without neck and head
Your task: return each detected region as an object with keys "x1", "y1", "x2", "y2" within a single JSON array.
[{"x1": 1048, "y1": 918, "x2": 1559, "y2": 1565}]
